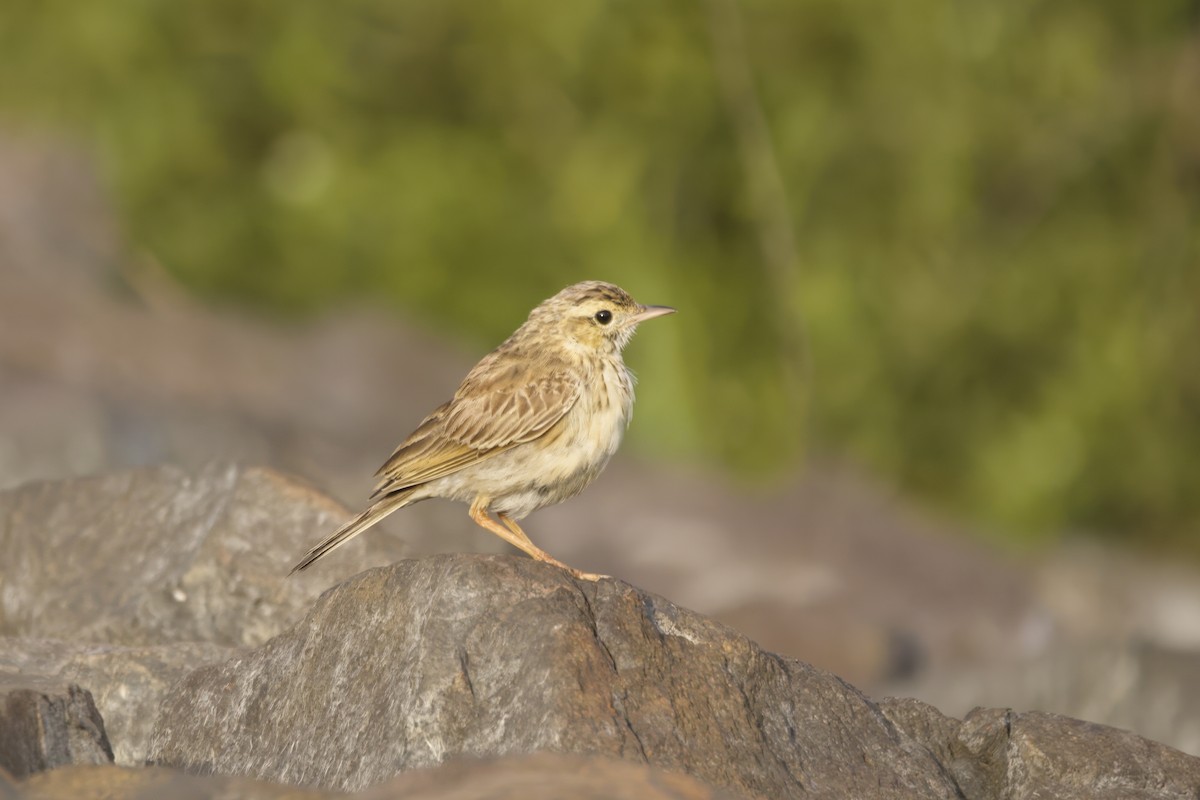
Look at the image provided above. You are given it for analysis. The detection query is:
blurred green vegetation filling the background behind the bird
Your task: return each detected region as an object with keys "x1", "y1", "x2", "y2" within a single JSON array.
[{"x1": 0, "y1": 0, "x2": 1200, "y2": 551}]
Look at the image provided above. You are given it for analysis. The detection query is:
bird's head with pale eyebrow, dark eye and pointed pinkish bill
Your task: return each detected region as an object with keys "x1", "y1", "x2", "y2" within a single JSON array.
[{"x1": 529, "y1": 281, "x2": 674, "y2": 353}]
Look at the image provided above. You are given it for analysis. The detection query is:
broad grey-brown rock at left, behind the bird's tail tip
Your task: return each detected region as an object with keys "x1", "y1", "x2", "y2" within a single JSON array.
[{"x1": 0, "y1": 463, "x2": 403, "y2": 646}]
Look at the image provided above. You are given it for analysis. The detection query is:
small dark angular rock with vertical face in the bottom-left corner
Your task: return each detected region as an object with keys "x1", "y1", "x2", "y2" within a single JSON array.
[{"x1": 0, "y1": 673, "x2": 113, "y2": 778}]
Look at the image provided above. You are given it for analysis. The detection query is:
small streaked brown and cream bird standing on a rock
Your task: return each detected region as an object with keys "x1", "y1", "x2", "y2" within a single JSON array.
[{"x1": 289, "y1": 281, "x2": 676, "y2": 581}]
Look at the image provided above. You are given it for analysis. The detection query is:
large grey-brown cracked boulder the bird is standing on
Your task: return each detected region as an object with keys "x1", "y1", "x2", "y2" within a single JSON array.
[{"x1": 151, "y1": 557, "x2": 956, "y2": 799}]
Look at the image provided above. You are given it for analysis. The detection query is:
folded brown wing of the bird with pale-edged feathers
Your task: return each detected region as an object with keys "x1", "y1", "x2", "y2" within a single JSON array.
[{"x1": 371, "y1": 368, "x2": 580, "y2": 497}]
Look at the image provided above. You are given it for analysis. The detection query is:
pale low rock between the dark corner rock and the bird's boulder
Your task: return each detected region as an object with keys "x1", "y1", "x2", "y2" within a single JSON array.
[{"x1": 0, "y1": 638, "x2": 233, "y2": 765}]
